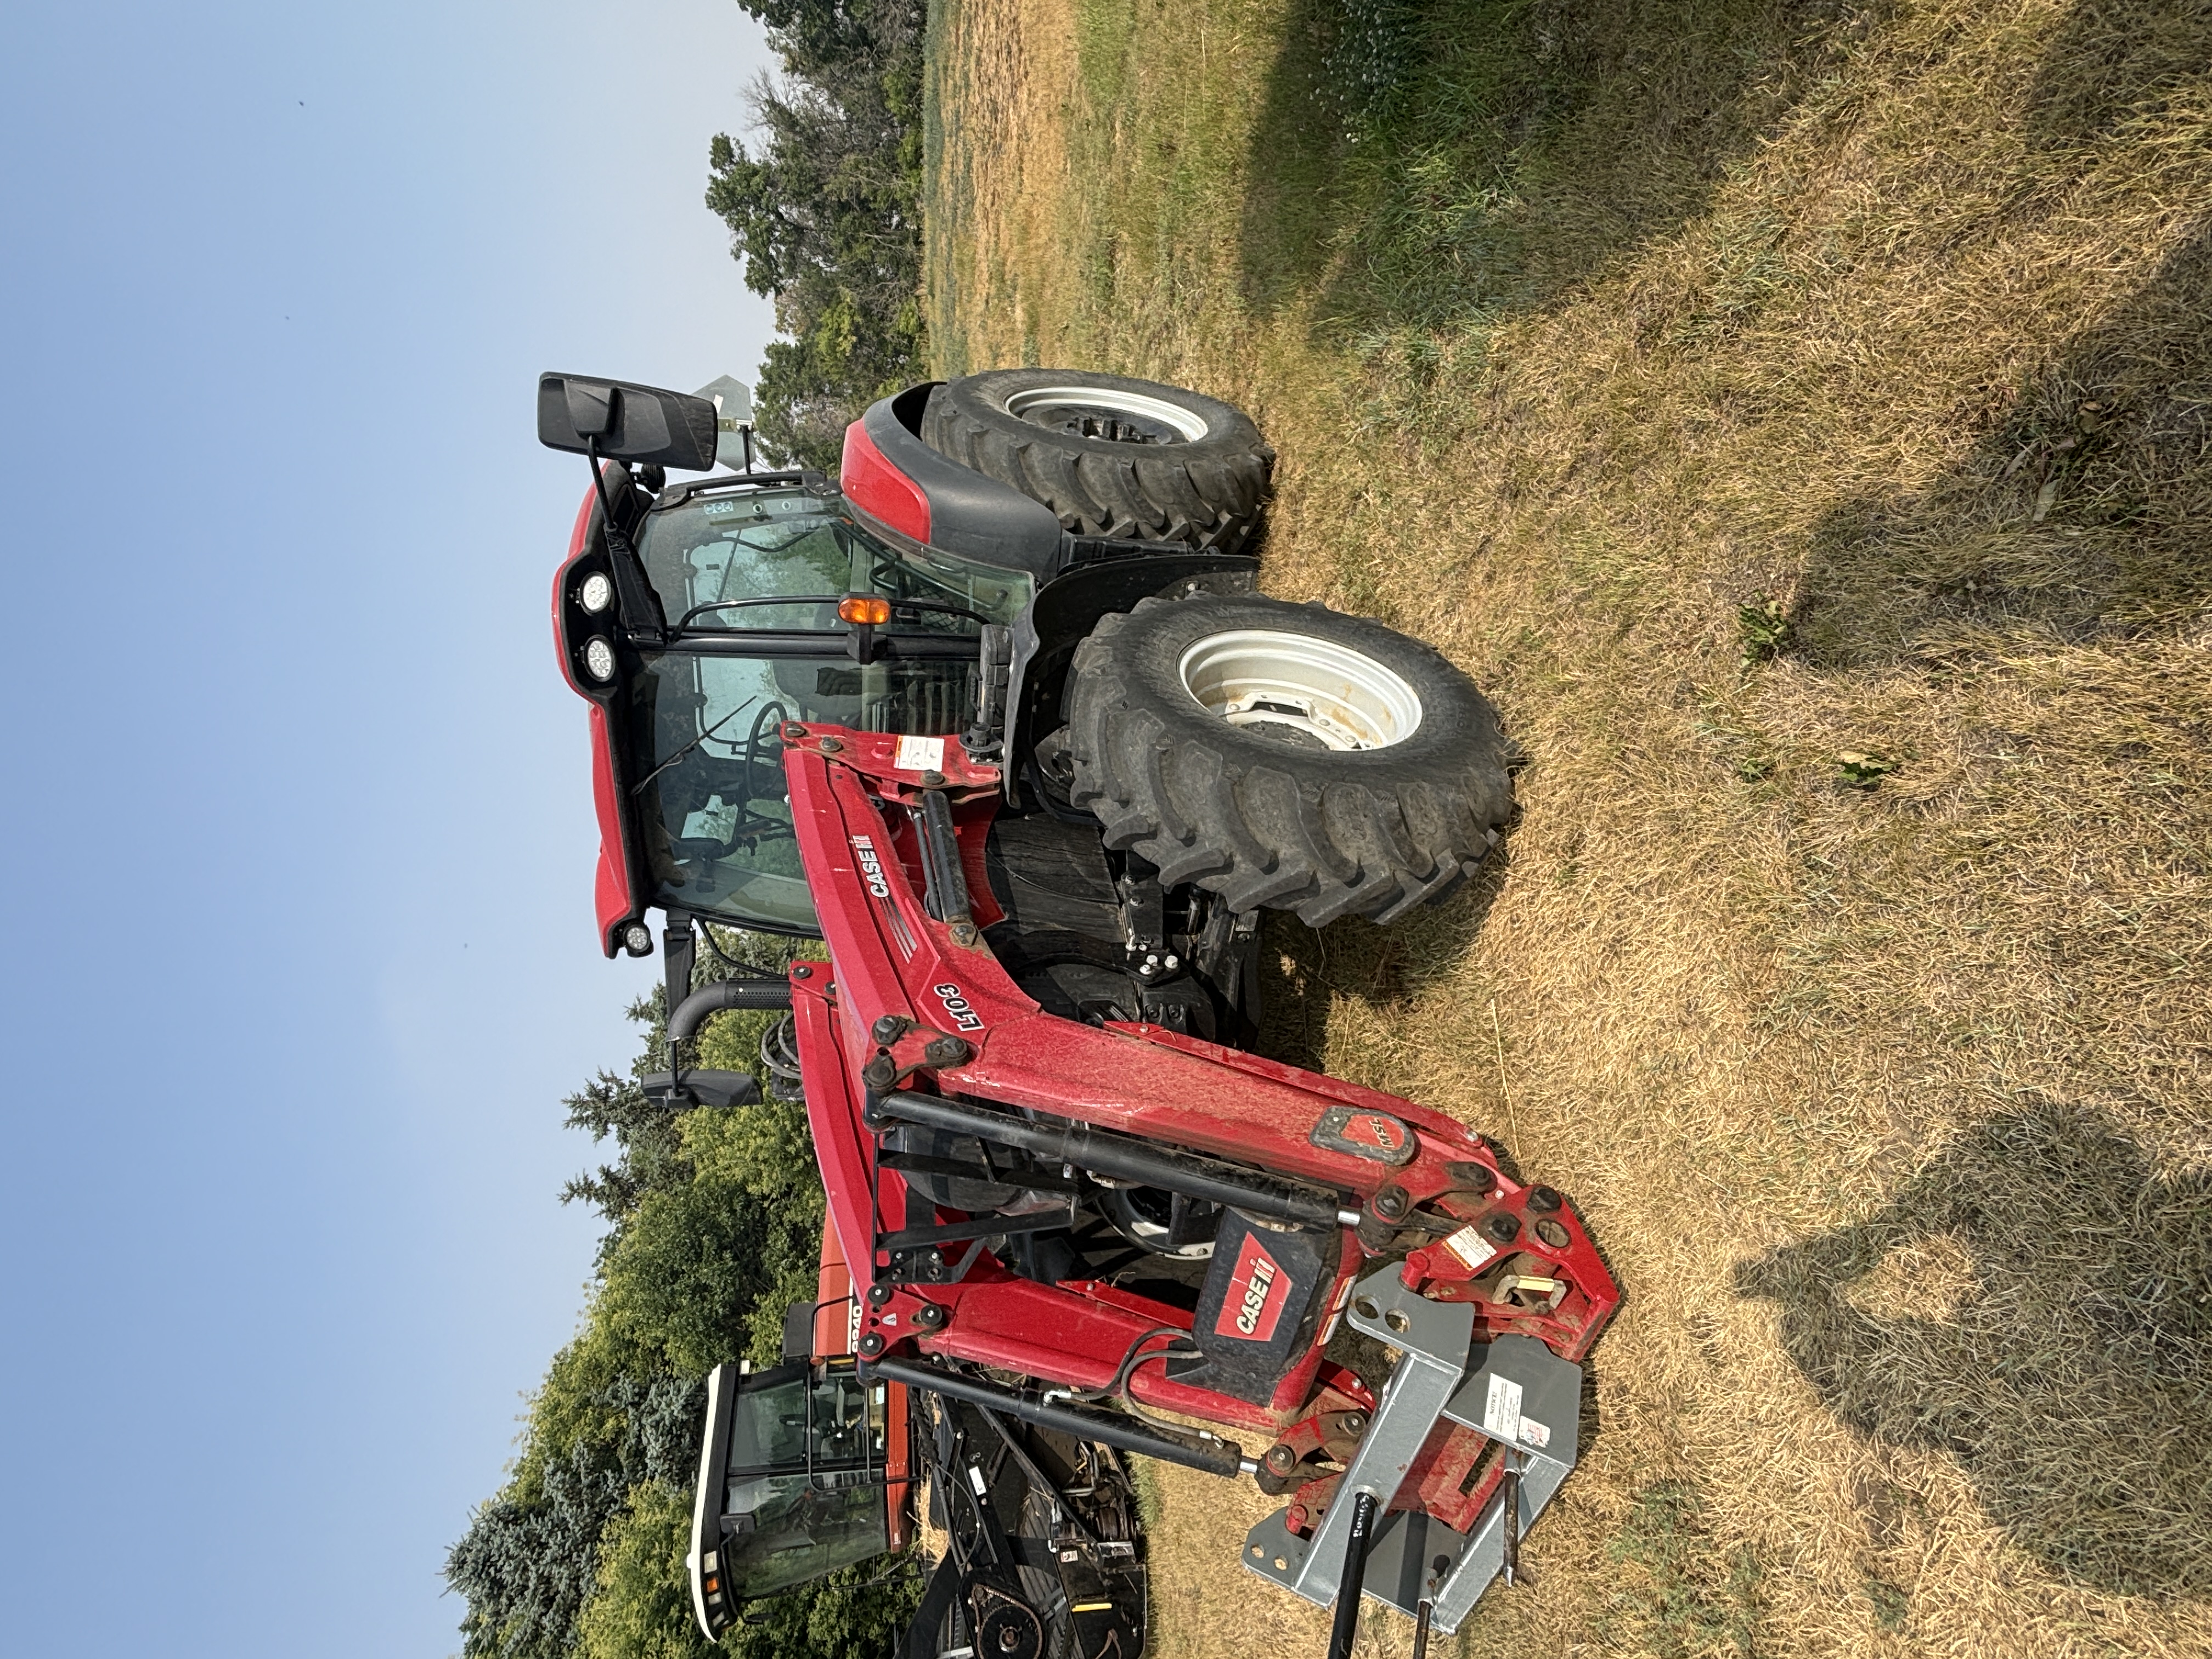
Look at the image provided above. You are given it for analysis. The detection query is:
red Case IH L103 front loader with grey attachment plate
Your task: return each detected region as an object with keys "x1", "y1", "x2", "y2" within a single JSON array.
[{"x1": 765, "y1": 723, "x2": 1619, "y2": 1630}]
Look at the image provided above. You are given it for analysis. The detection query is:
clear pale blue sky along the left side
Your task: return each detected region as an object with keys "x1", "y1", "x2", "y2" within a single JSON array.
[{"x1": 0, "y1": 0, "x2": 770, "y2": 1659}]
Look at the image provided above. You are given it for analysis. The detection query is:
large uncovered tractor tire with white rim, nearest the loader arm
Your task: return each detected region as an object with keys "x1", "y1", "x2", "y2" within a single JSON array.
[{"x1": 1066, "y1": 595, "x2": 1513, "y2": 927}]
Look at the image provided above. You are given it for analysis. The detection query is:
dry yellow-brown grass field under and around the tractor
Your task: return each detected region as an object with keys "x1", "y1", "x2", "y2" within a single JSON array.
[{"x1": 927, "y1": 0, "x2": 2212, "y2": 1657}]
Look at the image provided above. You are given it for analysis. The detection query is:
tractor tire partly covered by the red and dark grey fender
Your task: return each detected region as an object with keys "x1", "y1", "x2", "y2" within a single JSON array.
[{"x1": 922, "y1": 369, "x2": 1274, "y2": 553}]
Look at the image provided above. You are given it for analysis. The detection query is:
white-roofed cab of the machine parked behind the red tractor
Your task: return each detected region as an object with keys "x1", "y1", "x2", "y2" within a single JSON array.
[{"x1": 690, "y1": 1356, "x2": 907, "y2": 1637}]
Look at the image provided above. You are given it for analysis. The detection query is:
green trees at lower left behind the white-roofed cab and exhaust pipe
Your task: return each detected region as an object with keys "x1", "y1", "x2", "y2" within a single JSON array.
[{"x1": 444, "y1": 934, "x2": 918, "y2": 1659}]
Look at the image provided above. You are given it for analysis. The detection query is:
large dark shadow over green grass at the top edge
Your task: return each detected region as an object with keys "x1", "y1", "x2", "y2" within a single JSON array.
[{"x1": 1241, "y1": 0, "x2": 1880, "y2": 330}]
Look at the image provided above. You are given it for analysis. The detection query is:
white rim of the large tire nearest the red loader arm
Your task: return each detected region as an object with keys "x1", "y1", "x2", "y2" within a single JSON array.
[{"x1": 1177, "y1": 628, "x2": 1420, "y2": 750}]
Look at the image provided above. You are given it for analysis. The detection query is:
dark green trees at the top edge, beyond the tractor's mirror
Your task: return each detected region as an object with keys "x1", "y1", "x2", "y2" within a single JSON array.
[{"x1": 706, "y1": 0, "x2": 927, "y2": 473}]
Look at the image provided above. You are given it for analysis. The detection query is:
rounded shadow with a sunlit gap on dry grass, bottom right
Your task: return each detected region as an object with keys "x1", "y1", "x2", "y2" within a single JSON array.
[{"x1": 1736, "y1": 1106, "x2": 2212, "y2": 1599}]
